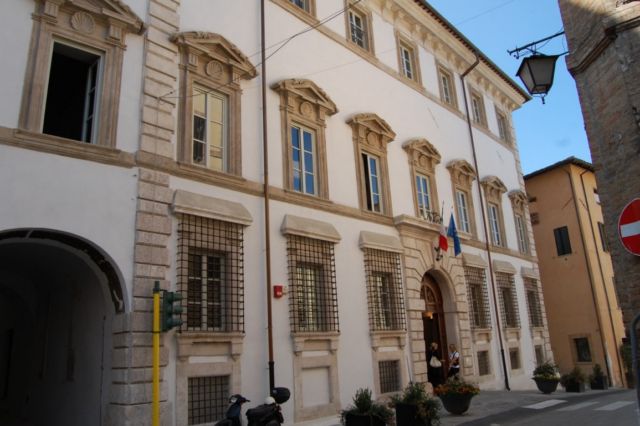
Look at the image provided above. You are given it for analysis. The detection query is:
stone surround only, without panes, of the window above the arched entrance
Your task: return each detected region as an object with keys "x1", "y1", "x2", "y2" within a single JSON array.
[{"x1": 402, "y1": 138, "x2": 442, "y2": 223}]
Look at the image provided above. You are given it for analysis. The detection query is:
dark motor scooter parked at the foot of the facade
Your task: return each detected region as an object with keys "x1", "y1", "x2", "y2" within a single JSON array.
[{"x1": 215, "y1": 388, "x2": 291, "y2": 426}]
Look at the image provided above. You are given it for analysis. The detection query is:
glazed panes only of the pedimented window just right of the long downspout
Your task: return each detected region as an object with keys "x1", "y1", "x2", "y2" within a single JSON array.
[{"x1": 291, "y1": 126, "x2": 316, "y2": 195}]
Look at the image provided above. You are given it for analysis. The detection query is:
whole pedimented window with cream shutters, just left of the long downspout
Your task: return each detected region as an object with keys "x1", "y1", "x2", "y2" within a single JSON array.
[{"x1": 172, "y1": 31, "x2": 257, "y2": 176}]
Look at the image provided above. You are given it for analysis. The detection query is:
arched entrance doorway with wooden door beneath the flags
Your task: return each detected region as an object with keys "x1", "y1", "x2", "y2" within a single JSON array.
[{"x1": 421, "y1": 273, "x2": 447, "y2": 373}]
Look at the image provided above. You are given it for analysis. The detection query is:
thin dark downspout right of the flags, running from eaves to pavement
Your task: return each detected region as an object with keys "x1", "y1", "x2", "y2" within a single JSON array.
[{"x1": 460, "y1": 51, "x2": 511, "y2": 390}]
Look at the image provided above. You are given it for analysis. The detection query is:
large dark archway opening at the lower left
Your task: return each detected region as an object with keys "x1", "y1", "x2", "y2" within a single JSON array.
[{"x1": 0, "y1": 229, "x2": 124, "y2": 426}]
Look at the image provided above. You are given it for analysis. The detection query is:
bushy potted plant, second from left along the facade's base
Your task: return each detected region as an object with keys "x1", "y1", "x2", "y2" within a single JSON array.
[{"x1": 391, "y1": 382, "x2": 440, "y2": 426}]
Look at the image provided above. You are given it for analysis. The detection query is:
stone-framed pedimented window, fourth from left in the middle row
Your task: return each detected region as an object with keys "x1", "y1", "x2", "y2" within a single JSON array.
[{"x1": 347, "y1": 114, "x2": 396, "y2": 216}]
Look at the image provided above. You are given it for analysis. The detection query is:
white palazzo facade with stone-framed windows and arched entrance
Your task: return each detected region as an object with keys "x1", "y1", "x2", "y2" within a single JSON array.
[{"x1": 0, "y1": 0, "x2": 552, "y2": 425}]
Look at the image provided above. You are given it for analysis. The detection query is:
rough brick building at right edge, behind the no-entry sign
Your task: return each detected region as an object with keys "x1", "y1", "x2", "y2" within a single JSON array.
[{"x1": 559, "y1": 0, "x2": 640, "y2": 327}]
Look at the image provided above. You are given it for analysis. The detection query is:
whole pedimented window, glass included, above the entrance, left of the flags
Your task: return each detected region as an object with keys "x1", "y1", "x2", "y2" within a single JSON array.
[{"x1": 402, "y1": 139, "x2": 441, "y2": 223}]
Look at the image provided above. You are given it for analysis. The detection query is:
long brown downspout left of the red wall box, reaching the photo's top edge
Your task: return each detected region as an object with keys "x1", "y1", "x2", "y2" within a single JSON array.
[{"x1": 260, "y1": 0, "x2": 275, "y2": 395}]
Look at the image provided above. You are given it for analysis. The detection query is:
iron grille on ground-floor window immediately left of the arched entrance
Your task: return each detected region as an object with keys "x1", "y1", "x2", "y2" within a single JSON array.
[{"x1": 364, "y1": 249, "x2": 406, "y2": 331}]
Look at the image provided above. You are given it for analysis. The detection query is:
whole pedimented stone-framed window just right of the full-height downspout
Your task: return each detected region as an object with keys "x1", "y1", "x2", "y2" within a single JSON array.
[{"x1": 271, "y1": 79, "x2": 338, "y2": 199}]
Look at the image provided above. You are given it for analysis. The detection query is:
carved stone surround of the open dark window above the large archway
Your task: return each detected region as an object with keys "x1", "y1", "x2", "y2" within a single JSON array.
[{"x1": 18, "y1": 0, "x2": 146, "y2": 148}]
